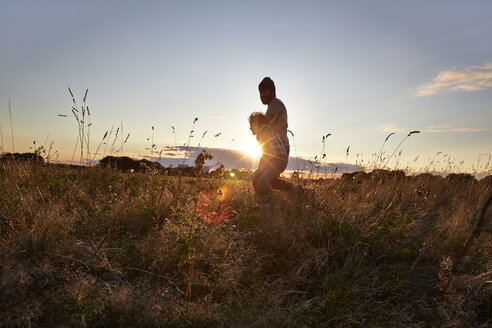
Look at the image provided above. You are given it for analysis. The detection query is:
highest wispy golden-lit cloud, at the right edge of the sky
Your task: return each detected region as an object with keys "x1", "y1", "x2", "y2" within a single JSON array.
[{"x1": 414, "y1": 62, "x2": 492, "y2": 97}]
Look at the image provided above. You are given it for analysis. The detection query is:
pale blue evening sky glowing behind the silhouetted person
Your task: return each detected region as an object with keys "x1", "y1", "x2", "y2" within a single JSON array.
[{"x1": 0, "y1": 0, "x2": 492, "y2": 170}]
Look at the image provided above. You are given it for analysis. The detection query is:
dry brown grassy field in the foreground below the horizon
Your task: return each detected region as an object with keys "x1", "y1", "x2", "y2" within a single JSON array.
[{"x1": 0, "y1": 162, "x2": 492, "y2": 327}]
